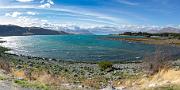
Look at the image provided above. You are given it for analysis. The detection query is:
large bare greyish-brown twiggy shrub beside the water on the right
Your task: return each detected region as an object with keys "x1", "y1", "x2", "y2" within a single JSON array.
[{"x1": 143, "y1": 49, "x2": 173, "y2": 74}]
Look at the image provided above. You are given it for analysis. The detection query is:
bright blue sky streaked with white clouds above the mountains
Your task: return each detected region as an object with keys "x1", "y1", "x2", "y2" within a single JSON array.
[{"x1": 0, "y1": 0, "x2": 180, "y2": 33}]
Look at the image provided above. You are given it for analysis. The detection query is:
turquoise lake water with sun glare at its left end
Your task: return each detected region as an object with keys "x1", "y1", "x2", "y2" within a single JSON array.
[{"x1": 2, "y1": 35, "x2": 180, "y2": 61}]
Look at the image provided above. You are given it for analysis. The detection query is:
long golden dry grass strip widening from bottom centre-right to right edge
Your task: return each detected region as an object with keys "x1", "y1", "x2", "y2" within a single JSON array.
[{"x1": 113, "y1": 69, "x2": 180, "y2": 90}]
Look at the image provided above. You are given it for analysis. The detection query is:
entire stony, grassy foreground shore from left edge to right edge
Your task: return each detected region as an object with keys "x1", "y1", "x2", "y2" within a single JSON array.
[{"x1": 0, "y1": 38, "x2": 180, "y2": 90}]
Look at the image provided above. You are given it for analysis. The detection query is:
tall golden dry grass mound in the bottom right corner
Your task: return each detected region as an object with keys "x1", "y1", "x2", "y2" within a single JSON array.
[{"x1": 142, "y1": 69, "x2": 180, "y2": 89}]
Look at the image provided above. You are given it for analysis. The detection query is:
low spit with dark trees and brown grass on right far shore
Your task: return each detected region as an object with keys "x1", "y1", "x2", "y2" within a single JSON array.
[{"x1": 107, "y1": 32, "x2": 180, "y2": 46}]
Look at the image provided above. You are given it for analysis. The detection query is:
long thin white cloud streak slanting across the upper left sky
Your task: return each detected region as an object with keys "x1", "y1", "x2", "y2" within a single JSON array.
[{"x1": 0, "y1": 4, "x2": 128, "y2": 24}]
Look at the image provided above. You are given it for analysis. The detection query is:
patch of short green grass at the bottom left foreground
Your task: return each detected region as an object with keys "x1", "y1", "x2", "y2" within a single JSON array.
[{"x1": 14, "y1": 80, "x2": 50, "y2": 90}]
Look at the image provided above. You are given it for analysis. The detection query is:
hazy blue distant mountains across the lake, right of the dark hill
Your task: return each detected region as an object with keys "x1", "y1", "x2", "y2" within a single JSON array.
[{"x1": 58, "y1": 26, "x2": 180, "y2": 35}]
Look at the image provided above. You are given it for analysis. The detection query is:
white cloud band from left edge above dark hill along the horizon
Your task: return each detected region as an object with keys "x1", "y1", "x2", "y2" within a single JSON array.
[{"x1": 0, "y1": 16, "x2": 179, "y2": 34}]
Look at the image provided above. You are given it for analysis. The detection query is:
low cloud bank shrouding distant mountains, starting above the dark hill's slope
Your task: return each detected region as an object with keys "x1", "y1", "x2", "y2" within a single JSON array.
[{"x1": 42, "y1": 24, "x2": 180, "y2": 34}]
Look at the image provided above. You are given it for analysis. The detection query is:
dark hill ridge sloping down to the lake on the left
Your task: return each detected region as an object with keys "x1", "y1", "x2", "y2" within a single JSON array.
[{"x1": 0, "y1": 25, "x2": 68, "y2": 36}]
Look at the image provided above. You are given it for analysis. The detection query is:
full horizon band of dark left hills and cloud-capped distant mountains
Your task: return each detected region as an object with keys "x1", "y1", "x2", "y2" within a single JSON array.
[{"x1": 0, "y1": 25, "x2": 180, "y2": 36}]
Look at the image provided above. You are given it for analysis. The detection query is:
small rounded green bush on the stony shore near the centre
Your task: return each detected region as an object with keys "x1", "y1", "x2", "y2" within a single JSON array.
[{"x1": 98, "y1": 61, "x2": 113, "y2": 70}]
